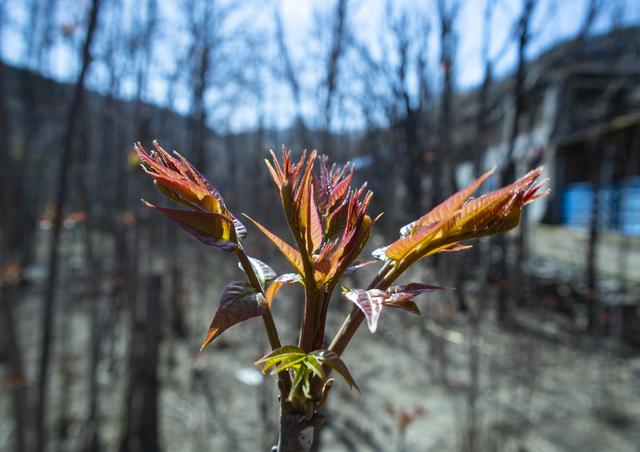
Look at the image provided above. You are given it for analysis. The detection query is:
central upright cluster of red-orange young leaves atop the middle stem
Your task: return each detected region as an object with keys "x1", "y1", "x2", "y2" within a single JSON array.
[{"x1": 252, "y1": 149, "x2": 374, "y2": 287}]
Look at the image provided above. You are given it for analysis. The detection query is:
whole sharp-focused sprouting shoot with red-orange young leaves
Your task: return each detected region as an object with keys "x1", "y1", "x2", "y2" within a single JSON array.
[{"x1": 135, "y1": 143, "x2": 547, "y2": 428}]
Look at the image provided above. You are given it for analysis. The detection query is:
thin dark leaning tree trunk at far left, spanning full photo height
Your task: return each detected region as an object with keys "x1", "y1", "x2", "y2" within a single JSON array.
[{"x1": 36, "y1": 0, "x2": 100, "y2": 452}]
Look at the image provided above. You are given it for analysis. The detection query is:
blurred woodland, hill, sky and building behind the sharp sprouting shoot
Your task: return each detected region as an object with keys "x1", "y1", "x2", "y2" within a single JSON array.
[{"x1": 0, "y1": 0, "x2": 640, "y2": 452}]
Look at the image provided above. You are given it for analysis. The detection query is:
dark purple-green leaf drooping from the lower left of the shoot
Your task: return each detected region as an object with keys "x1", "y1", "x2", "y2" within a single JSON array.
[{"x1": 200, "y1": 281, "x2": 268, "y2": 351}]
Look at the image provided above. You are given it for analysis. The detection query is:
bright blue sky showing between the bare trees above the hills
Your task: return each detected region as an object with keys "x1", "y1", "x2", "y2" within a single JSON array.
[{"x1": 1, "y1": 0, "x2": 640, "y2": 130}]
